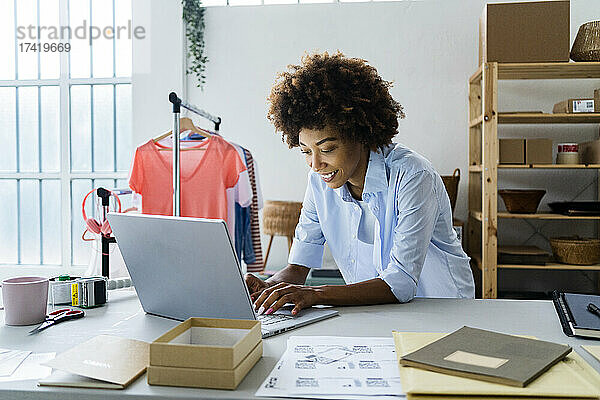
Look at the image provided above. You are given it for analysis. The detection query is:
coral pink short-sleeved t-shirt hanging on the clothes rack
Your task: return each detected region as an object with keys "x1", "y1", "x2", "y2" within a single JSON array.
[{"x1": 129, "y1": 135, "x2": 246, "y2": 227}]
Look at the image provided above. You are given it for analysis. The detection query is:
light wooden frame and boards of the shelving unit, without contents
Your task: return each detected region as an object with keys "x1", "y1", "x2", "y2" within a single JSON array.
[{"x1": 468, "y1": 62, "x2": 600, "y2": 299}]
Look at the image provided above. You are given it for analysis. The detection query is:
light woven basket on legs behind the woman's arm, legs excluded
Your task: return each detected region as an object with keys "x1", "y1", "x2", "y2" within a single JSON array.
[{"x1": 263, "y1": 200, "x2": 302, "y2": 237}]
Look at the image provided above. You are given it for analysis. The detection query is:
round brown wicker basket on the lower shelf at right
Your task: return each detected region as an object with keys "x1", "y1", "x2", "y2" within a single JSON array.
[{"x1": 550, "y1": 237, "x2": 600, "y2": 265}]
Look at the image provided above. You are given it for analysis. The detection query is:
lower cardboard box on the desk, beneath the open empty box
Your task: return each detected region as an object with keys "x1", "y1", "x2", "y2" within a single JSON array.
[{"x1": 148, "y1": 341, "x2": 263, "y2": 390}]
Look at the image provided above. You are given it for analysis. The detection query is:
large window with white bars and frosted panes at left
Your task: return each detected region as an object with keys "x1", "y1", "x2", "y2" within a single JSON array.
[{"x1": 0, "y1": 0, "x2": 132, "y2": 270}]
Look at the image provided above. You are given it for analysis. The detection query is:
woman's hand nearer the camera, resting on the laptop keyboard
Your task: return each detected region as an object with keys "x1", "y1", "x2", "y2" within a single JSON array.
[{"x1": 254, "y1": 282, "x2": 321, "y2": 315}]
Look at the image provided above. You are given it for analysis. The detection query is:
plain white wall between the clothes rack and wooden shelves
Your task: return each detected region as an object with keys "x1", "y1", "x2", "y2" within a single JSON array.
[{"x1": 188, "y1": 1, "x2": 480, "y2": 267}]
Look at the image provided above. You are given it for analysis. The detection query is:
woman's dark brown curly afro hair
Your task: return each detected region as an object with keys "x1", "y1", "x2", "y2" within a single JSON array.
[{"x1": 267, "y1": 52, "x2": 404, "y2": 150}]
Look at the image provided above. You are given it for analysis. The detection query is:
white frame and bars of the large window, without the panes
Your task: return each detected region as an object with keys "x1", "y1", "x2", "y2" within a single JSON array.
[{"x1": 0, "y1": 0, "x2": 132, "y2": 275}]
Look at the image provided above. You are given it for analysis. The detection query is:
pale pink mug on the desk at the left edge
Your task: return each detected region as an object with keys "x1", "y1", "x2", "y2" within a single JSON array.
[{"x1": 2, "y1": 276, "x2": 48, "y2": 325}]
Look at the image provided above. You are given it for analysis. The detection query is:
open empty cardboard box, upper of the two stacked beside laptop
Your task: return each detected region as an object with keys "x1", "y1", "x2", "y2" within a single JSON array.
[{"x1": 150, "y1": 318, "x2": 262, "y2": 370}]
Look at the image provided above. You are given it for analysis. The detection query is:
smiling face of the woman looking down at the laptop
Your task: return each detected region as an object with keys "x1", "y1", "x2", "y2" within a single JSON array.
[{"x1": 299, "y1": 127, "x2": 368, "y2": 189}]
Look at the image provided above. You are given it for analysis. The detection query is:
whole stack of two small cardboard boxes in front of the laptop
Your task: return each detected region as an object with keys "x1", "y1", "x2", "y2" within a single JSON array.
[{"x1": 148, "y1": 318, "x2": 262, "y2": 389}]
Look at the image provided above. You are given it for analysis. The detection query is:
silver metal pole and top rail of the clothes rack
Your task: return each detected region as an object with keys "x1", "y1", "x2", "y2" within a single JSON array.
[{"x1": 169, "y1": 92, "x2": 221, "y2": 217}]
